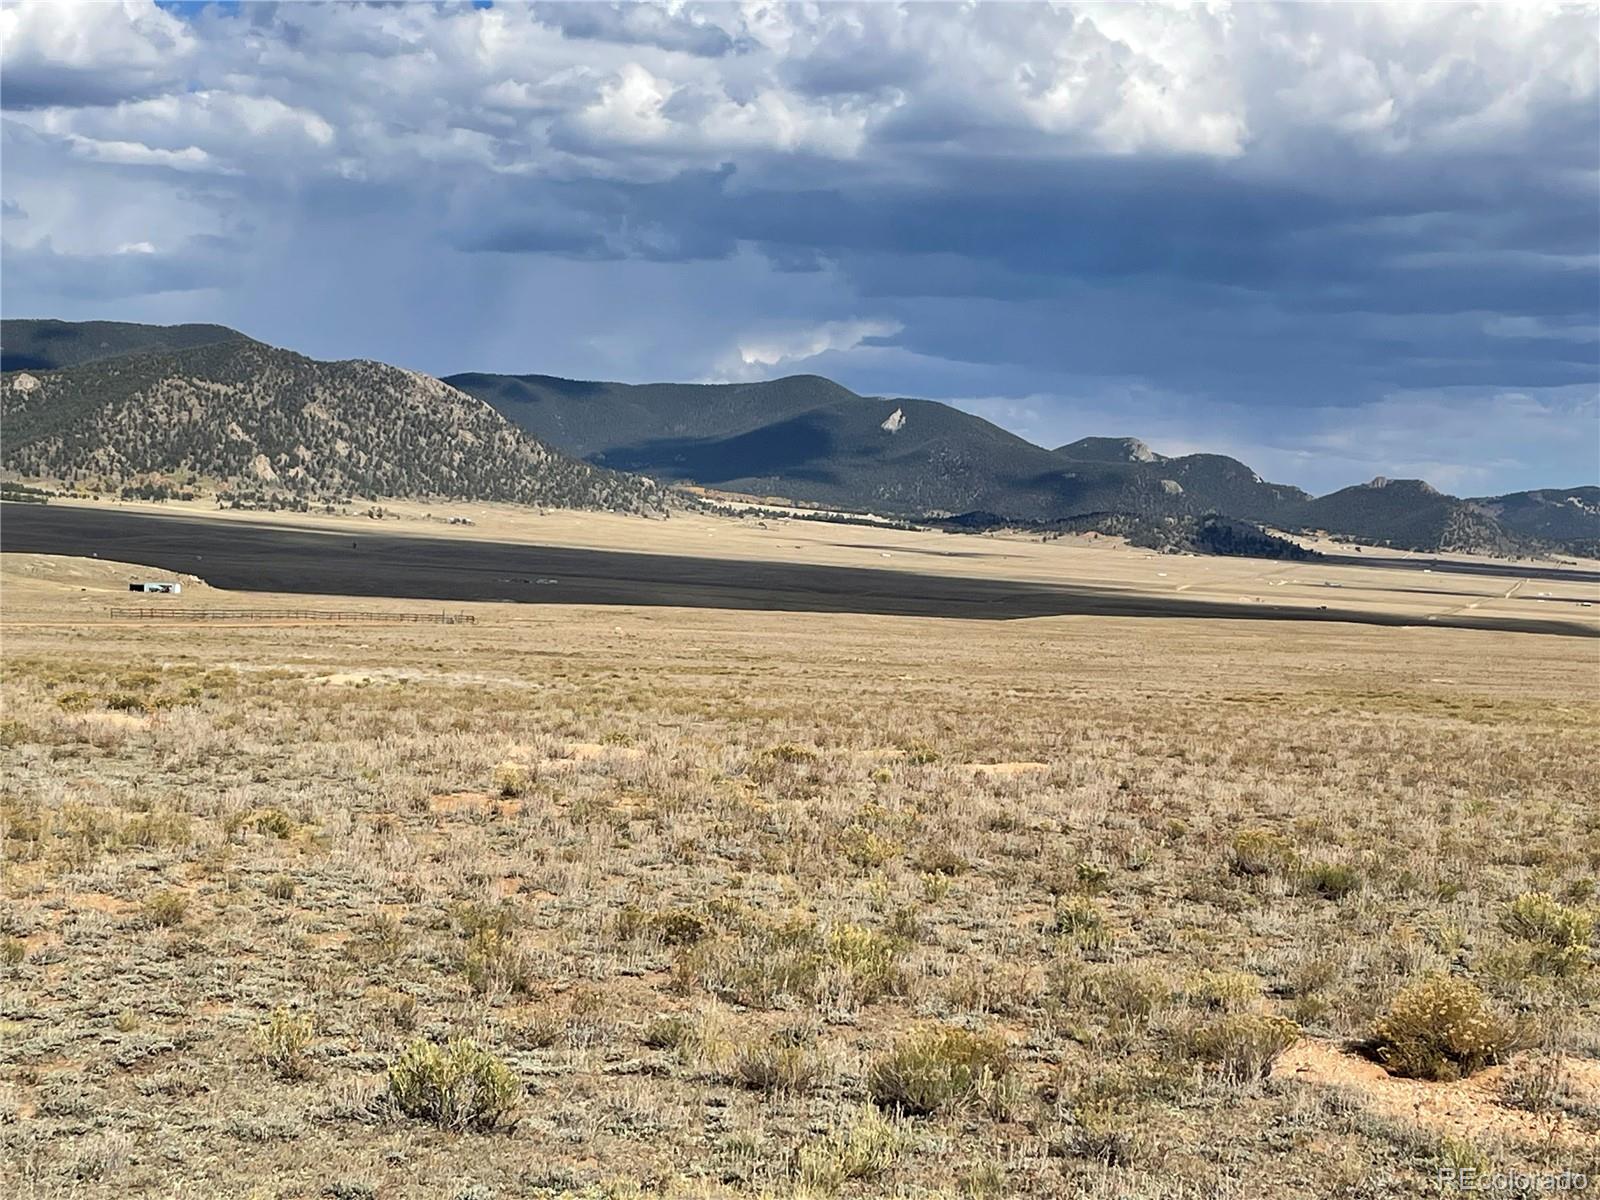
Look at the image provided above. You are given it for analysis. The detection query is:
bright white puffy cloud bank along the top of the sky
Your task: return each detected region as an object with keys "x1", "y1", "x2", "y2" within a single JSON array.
[{"x1": 9, "y1": 0, "x2": 1600, "y2": 197}]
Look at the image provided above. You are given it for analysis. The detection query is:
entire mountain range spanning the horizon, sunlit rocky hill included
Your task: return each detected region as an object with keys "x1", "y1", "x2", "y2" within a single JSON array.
[{"x1": 0, "y1": 320, "x2": 1600, "y2": 554}]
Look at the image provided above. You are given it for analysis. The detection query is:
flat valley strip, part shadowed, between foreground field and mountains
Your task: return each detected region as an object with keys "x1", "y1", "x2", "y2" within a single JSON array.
[{"x1": 0, "y1": 506, "x2": 1600, "y2": 637}]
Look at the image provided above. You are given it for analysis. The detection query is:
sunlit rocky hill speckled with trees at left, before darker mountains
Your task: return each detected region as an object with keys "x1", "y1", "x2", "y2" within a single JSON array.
[{"x1": 0, "y1": 336, "x2": 664, "y2": 510}]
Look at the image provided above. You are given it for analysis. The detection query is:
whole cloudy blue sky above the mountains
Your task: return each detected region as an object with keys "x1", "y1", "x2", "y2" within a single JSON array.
[{"x1": 0, "y1": 0, "x2": 1600, "y2": 494}]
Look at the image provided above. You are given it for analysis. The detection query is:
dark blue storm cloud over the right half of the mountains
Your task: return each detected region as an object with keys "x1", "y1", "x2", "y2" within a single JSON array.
[{"x1": 441, "y1": 140, "x2": 1595, "y2": 403}]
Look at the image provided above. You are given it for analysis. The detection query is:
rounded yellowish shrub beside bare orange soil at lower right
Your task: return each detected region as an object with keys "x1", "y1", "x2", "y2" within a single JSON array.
[{"x1": 1373, "y1": 974, "x2": 1512, "y2": 1080}]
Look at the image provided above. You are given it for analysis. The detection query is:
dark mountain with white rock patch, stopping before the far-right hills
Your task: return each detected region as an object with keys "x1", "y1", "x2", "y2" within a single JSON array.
[{"x1": 446, "y1": 374, "x2": 1306, "y2": 520}]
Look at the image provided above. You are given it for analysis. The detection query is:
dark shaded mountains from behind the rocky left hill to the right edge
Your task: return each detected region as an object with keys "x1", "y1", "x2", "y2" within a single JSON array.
[{"x1": 446, "y1": 373, "x2": 1600, "y2": 554}]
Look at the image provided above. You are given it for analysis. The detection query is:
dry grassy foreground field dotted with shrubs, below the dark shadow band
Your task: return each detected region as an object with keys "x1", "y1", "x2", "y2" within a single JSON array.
[{"x1": 0, "y1": 547, "x2": 1600, "y2": 1197}]
